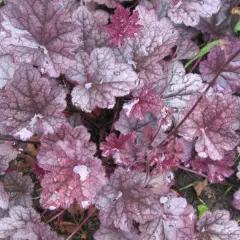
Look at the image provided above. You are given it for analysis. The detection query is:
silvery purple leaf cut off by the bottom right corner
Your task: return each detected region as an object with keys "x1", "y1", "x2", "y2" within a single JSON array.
[{"x1": 193, "y1": 210, "x2": 240, "y2": 240}]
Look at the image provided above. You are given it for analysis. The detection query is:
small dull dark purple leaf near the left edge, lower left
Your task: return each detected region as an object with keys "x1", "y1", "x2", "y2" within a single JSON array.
[{"x1": 3, "y1": 171, "x2": 34, "y2": 207}]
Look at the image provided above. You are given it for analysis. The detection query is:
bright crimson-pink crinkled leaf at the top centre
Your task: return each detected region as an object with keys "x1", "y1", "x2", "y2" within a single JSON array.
[{"x1": 105, "y1": 4, "x2": 141, "y2": 46}]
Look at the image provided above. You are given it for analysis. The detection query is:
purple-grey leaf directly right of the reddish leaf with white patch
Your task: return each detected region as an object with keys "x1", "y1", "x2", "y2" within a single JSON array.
[{"x1": 96, "y1": 168, "x2": 161, "y2": 231}]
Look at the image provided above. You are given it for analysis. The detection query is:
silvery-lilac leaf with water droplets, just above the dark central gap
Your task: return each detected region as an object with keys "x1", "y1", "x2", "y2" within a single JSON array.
[{"x1": 66, "y1": 48, "x2": 138, "y2": 112}]
